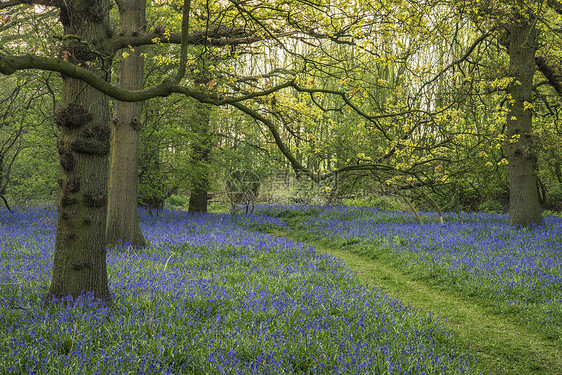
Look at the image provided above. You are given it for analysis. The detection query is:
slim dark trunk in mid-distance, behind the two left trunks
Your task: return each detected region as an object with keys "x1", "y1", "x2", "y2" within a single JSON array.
[{"x1": 188, "y1": 102, "x2": 211, "y2": 212}]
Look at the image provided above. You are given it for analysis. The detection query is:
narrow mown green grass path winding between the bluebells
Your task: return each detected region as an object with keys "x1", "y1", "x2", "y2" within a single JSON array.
[{"x1": 266, "y1": 233, "x2": 562, "y2": 375}]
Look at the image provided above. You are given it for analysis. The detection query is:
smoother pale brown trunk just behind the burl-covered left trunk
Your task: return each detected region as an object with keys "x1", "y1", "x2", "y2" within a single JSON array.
[{"x1": 106, "y1": 0, "x2": 146, "y2": 246}]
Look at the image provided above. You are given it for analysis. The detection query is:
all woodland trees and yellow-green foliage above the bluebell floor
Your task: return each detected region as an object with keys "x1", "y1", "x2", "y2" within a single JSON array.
[{"x1": 0, "y1": 0, "x2": 562, "y2": 298}]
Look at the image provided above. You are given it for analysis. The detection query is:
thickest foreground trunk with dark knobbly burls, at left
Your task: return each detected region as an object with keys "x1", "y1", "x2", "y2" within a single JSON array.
[{"x1": 49, "y1": 0, "x2": 111, "y2": 300}]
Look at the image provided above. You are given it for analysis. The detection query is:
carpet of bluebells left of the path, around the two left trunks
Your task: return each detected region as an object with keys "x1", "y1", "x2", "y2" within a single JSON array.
[{"x1": 0, "y1": 209, "x2": 476, "y2": 374}]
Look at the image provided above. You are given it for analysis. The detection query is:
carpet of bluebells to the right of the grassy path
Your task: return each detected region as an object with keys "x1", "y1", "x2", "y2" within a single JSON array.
[{"x1": 254, "y1": 206, "x2": 562, "y2": 341}]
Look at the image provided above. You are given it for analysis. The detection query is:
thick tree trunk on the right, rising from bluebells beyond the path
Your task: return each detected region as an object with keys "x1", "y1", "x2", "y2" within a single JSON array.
[{"x1": 506, "y1": 17, "x2": 542, "y2": 226}]
